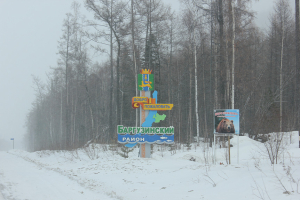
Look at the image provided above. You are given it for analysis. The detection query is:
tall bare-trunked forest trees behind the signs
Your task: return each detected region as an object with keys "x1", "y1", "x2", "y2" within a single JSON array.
[{"x1": 25, "y1": 0, "x2": 300, "y2": 151}]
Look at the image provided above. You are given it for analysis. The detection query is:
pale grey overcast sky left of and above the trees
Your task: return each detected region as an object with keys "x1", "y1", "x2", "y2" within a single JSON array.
[{"x1": 0, "y1": 0, "x2": 295, "y2": 148}]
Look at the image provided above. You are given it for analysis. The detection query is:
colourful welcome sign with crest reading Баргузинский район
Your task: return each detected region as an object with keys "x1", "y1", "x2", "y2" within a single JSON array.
[{"x1": 118, "y1": 69, "x2": 174, "y2": 145}]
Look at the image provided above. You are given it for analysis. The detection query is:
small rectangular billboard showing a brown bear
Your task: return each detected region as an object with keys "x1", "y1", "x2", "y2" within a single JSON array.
[{"x1": 214, "y1": 109, "x2": 240, "y2": 134}]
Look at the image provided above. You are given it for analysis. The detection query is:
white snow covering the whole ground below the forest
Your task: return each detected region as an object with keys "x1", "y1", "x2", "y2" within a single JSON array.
[{"x1": 0, "y1": 132, "x2": 300, "y2": 200}]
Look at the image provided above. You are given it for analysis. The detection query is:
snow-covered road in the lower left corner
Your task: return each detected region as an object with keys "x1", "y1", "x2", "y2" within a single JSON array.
[{"x1": 0, "y1": 152, "x2": 112, "y2": 200}]
